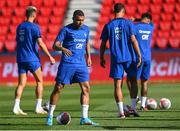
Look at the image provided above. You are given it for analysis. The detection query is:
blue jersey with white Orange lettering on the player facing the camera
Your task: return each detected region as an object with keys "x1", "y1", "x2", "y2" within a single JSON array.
[{"x1": 56, "y1": 24, "x2": 89, "y2": 65}]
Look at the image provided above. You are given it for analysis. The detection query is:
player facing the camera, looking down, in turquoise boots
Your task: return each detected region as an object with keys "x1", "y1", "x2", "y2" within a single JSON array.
[{"x1": 47, "y1": 10, "x2": 97, "y2": 126}]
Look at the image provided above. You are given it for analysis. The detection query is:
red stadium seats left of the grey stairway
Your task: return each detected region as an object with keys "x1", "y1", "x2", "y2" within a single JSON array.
[{"x1": 0, "y1": 0, "x2": 68, "y2": 52}]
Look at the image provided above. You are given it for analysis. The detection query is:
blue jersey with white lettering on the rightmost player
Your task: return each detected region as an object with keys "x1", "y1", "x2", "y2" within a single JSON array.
[{"x1": 135, "y1": 22, "x2": 154, "y2": 61}]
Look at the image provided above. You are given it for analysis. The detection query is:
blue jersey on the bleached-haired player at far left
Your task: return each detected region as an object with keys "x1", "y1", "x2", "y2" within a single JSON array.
[{"x1": 16, "y1": 21, "x2": 41, "y2": 62}]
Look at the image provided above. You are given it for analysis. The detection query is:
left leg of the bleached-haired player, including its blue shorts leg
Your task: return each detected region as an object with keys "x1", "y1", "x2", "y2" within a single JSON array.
[{"x1": 13, "y1": 63, "x2": 27, "y2": 115}]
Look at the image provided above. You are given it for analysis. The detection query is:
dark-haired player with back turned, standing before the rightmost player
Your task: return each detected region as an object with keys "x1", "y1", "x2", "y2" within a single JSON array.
[{"x1": 100, "y1": 3, "x2": 141, "y2": 118}]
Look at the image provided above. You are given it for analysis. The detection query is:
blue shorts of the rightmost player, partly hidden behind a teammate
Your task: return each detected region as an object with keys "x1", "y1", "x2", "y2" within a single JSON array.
[{"x1": 137, "y1": 61, "x2": 151, "y2": 80}]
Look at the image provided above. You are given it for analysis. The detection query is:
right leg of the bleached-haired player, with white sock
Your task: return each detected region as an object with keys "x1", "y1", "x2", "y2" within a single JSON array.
[{"x1": 33, "y1": 67, "x2": 47, "y2": 114}]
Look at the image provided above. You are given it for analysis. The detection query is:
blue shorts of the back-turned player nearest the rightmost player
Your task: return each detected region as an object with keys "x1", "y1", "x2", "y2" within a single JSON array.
[{"x1": 109, "y1": 61, "x2": 136, "y2": 79}]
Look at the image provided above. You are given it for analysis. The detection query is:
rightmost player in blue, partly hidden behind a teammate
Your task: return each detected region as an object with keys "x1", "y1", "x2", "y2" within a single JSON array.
[{"x1": 127, "y1": 12, "x2": 154, "y2": 111}]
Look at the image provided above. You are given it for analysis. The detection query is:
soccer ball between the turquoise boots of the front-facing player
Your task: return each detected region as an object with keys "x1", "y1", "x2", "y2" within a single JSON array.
[{"x1": 56, "y1": 112, "x2": 71, "y2": 125}]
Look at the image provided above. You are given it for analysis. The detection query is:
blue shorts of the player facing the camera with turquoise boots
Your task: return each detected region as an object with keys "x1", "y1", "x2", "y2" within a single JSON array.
[{"x1": 56, "y1": 64, "x2": 89, "y2": 84}]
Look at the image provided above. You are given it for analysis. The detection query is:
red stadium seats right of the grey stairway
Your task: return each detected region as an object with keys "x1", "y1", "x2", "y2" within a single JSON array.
[{"x1": 93, "y1": 0, "x2": 180, "y2": 49}]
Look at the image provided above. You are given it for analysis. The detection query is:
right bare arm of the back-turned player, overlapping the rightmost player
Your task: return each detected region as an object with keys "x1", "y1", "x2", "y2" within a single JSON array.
[{"x1": 131, "y1": 35, "x2": 142, "y2": 67}]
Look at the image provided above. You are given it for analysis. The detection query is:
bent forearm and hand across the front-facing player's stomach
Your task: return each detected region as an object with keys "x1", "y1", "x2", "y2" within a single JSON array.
[{"x1": 53, "y1": 41, "x2": 72, "y2": 56}]
